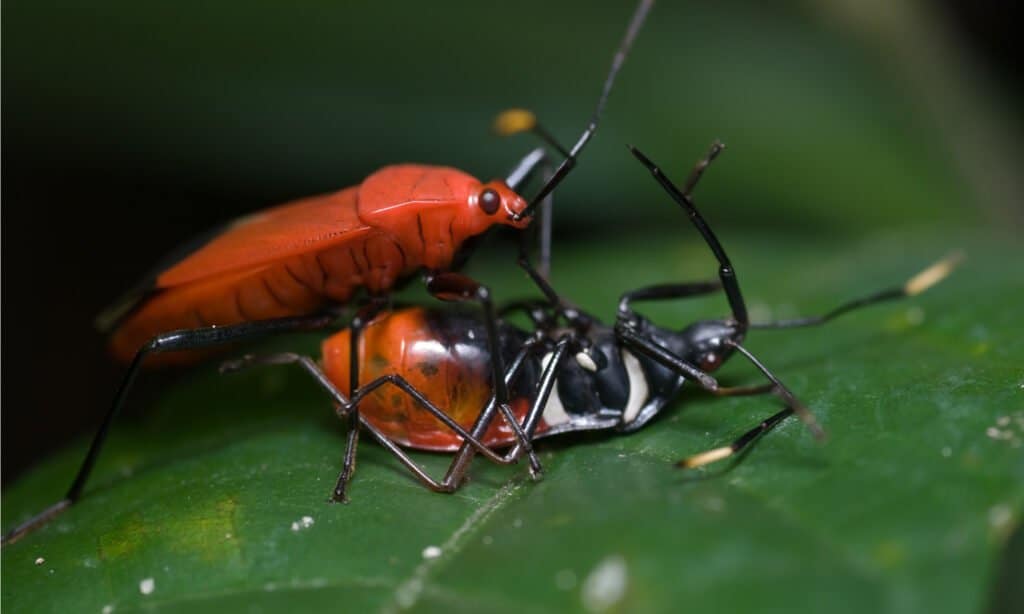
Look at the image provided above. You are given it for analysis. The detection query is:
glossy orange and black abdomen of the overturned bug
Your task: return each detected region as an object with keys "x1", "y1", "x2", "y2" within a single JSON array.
[{"x1": 322, "y1": 308, "x2": 547, "y2": 451}]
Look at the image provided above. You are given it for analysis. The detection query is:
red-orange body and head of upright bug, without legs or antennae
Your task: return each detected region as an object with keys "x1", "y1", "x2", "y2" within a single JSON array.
[{"x1": 111, "y1": 165, "x2": 526, "y2": 362}]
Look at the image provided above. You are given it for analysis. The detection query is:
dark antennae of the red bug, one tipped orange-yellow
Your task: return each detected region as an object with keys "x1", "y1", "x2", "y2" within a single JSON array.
[{"x1": 495, "y1": 0, "x2": 654, "y2": 221}]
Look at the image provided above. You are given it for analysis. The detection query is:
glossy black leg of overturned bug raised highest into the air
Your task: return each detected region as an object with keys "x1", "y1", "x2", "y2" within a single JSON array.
[{"x1": 630, "y1": 142, "x2": 750, "y2": 331}]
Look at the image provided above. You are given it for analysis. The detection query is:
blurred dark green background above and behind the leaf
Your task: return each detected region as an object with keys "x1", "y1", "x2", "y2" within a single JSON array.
[{"x1": 2, "y1": 0, "x2": 1022, "y2": 483}]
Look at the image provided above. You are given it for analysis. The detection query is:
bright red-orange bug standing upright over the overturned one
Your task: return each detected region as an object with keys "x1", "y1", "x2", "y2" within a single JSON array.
[{"x1": 3, "y1": 0, "x2": 653, "y2": 543}]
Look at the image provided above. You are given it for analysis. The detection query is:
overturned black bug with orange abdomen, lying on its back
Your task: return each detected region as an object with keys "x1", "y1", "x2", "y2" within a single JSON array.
[{"x1": 207, "y1": 143, "x2": 957, "y2": 494}]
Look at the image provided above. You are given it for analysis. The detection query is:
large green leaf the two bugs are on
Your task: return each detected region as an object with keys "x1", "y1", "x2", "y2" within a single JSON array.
[{"x1": 2, "y1": 232, "x2": 1024, "y2": 613}]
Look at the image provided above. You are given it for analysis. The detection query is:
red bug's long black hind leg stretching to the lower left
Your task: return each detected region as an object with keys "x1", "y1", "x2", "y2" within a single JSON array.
[{"x1": 2, "y1": 313, "x2": 337, "y2": 544}]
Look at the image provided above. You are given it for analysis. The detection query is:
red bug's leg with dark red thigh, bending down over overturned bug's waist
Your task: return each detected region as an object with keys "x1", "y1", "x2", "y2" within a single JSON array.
[{"x1": 427, "y1": 272, "x2": 543, "y2": 477}]
